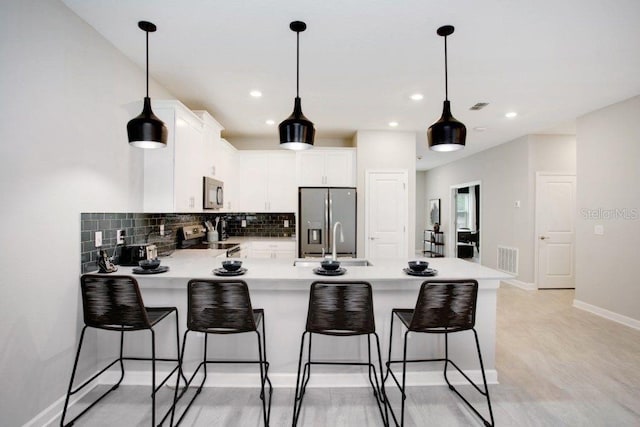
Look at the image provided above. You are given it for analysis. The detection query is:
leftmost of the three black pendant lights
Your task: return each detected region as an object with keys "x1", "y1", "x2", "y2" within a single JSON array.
[{"x1": 127, "y1": 21, "x2": 167, "y2": 148}]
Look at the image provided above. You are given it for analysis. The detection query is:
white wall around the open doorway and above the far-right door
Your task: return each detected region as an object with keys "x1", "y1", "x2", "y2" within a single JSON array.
[{"x1": 418, "y1": 135, "x2": 576, "y2": 283}]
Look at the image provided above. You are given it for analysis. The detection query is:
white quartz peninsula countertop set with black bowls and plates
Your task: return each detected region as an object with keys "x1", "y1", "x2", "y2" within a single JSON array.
[{"x1": 110, "y1": 251, "x2": 512, "y2": 289}]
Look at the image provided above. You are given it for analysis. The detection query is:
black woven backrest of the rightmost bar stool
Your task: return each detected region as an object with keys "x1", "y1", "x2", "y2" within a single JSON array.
[{"x1": 409, "y1": 279, "x2": 478, "y2": 332}]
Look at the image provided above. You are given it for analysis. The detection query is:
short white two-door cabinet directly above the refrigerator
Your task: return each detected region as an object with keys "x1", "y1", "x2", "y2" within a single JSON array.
[{"x1": 296, "y1": 148, "x2": 356, "y2": 187}]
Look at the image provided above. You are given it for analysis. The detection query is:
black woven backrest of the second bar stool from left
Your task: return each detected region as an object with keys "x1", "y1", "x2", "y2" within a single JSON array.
[{"x1": 187, "y1": 279, "x2": 256, "y2": 334}]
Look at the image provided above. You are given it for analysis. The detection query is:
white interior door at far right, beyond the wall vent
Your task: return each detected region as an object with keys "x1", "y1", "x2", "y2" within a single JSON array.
[{"x1": 536, "y1": 173, "x2": 576, "y2": 288}]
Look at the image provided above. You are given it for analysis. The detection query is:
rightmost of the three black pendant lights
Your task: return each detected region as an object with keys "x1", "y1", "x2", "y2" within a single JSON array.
[{"x1": 427, "y1": 25, "x2": 467, "y2": 151}]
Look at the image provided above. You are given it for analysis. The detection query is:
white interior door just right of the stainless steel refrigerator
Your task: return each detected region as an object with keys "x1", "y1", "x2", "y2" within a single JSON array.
[{"x1": 365, "y1": 171, "x2": 409, "y2": 258}]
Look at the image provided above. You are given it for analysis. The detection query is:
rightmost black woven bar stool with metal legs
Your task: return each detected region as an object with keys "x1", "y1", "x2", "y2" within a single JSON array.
[{"x1": 384, "y1": 279, "x2": 494, "y2": 426}]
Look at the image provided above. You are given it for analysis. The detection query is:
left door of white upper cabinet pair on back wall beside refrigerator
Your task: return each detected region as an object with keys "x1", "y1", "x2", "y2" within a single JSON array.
[{"x1": 236, "y1": 152, "x2": 267, "y2": 212}]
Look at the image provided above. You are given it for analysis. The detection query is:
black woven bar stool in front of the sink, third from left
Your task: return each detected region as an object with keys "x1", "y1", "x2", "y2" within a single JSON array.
[{"x1": 293, "y1": 281, "x2": 388, "y2": 427}]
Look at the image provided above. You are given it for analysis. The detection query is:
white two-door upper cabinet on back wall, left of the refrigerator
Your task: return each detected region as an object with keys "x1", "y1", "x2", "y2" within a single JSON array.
[{"x1": 238, "y1": 150, "x2": 298, "y2": 212}]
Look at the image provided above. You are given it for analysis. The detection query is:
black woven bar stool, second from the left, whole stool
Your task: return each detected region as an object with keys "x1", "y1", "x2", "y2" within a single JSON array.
[{"x1": 171, "y1": 279, "x2": 273, "y2": 426}]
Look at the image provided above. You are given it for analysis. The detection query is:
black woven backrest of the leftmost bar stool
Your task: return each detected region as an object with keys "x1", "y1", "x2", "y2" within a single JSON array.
[{"x1": 80, "y1": 274, "x2": 151, "y2": 331}]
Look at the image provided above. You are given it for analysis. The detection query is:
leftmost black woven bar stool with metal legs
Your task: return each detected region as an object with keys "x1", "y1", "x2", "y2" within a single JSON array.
[{"x1": 60, "y1": 274, "x2": 180, "y2": 426}]
